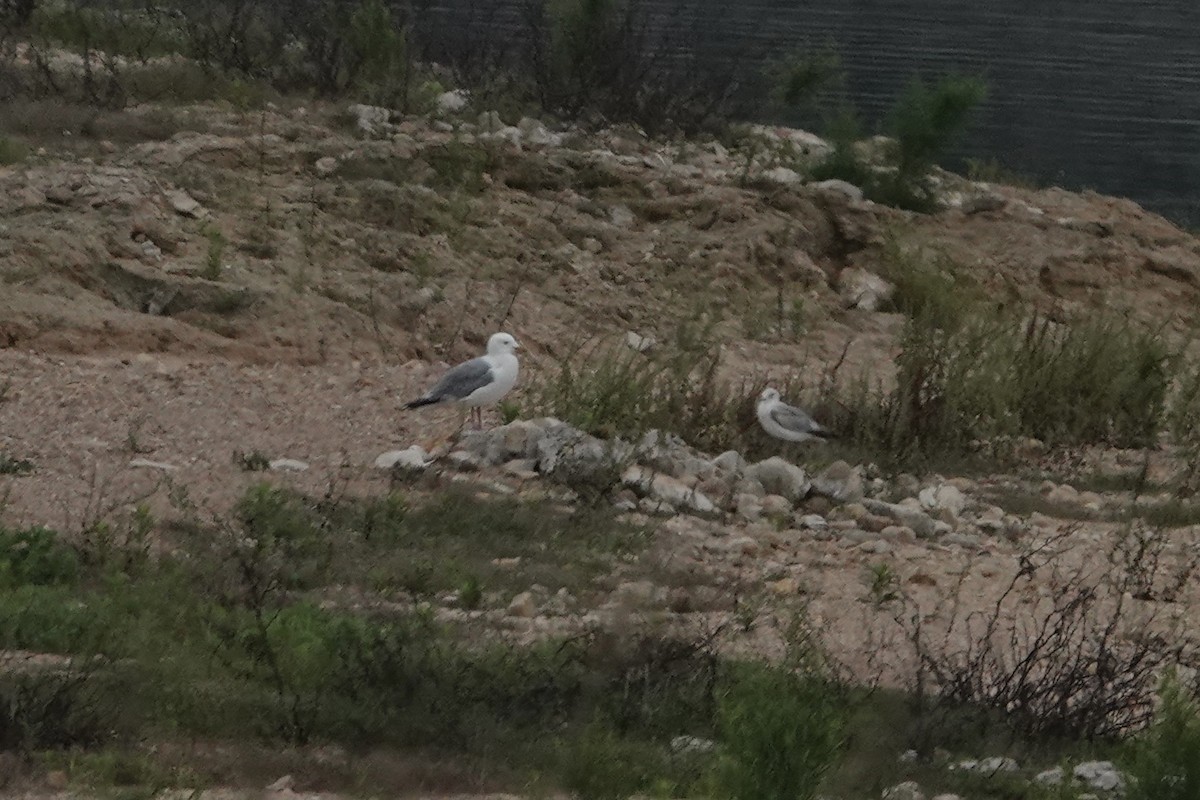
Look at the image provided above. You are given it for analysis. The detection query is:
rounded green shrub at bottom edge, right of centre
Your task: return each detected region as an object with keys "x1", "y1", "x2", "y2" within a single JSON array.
[{"x1": 718, "y1": 664, "x2": 845, "y2": 800}]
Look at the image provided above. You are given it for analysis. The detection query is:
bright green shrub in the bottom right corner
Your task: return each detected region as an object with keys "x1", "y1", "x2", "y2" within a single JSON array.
[{"x1": 1124, "y1": 676, "x2": 1200, "y2": 800}]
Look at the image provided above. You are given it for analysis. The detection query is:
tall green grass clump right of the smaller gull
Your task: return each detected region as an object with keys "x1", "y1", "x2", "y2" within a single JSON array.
[{"x1": 824, "y1": 307, "x2": 1175, "y2": 459}]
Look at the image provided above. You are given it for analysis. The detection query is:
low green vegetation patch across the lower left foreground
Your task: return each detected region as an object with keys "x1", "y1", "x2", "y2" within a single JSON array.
[{"x1": 0, "y1": 496, "x2": 859, "y2": 798}]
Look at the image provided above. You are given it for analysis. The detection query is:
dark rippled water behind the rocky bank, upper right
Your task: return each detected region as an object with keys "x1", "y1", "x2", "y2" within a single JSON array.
[{"x1": 431, "y1": 0, "x2": 1200, "y2": 224}]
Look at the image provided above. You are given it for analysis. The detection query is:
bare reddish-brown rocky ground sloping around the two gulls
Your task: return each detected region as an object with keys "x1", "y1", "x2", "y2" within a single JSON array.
[{"x1": 0, "y1": 97, "x2": 1200, "y2": 800}]
